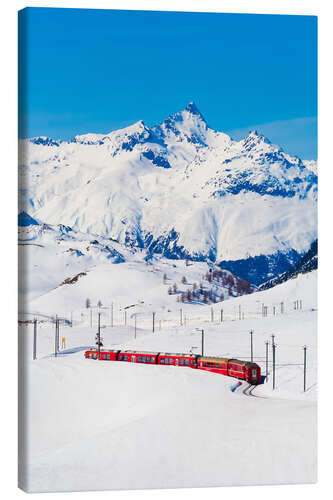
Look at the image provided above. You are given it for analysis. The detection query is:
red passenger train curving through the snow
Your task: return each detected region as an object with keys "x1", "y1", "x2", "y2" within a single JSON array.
[{"x1": 85, "y1": 347, "x2": 261, "y2": 385}]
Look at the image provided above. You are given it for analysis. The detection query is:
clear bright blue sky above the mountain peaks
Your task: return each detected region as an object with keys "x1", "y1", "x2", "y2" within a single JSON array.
[{"x1": 19, "y1": 8, "x2": 317, "y2": 159}]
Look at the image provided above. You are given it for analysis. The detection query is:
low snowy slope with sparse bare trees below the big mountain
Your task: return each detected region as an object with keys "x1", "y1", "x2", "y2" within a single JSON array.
[{"x1": 18, "y1": 212, "x2": 255, "y2": 313}]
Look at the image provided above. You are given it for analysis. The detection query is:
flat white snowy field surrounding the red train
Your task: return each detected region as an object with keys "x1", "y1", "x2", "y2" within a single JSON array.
[{"x1": 19, "y1": 265, "x2": 317, "y2": 492}]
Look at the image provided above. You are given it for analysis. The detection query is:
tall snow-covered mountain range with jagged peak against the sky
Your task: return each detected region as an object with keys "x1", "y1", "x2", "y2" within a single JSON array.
[{"x1": 19, "y1": 103, "x2": 317, "y2": 284}]
